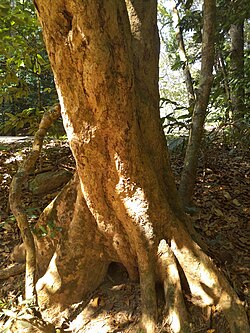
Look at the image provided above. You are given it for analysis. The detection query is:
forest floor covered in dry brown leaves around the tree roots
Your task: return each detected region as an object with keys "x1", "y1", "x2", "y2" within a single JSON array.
[{"x1": 0, "y1": 136, "x2": 250, "y2": 333}]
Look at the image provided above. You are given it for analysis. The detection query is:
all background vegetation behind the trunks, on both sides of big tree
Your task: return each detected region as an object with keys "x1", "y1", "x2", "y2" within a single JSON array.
[{"x1": 0, "y1": 0, "x2": 250, "y2": 147}]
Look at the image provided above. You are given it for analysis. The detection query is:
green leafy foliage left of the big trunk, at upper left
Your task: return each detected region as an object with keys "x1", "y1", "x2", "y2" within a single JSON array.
[{"x1": 0, "y1": 0, "x2": 56, "y2": 134}]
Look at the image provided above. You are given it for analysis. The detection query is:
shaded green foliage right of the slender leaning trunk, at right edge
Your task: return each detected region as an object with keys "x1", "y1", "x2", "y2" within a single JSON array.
[{"x1": 209, "y1": 0, "x2": 250, "y2": 140}]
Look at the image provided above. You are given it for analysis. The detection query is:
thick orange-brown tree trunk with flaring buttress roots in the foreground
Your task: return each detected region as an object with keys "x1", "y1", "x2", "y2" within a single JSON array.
[{"x1": 35, "y1": 0, "x2": 248, "y2": 333}]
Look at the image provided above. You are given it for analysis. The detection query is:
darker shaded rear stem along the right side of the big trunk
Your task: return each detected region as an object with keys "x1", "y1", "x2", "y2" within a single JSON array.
[{"x1": 126, "y1": 0, "x2": 196, "y2": 237}]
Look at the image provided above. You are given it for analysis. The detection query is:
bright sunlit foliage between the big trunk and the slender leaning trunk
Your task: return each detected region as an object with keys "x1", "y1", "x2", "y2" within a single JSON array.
[{"x1": 158, "y1": 0, "x2": 202, "y2": 134}]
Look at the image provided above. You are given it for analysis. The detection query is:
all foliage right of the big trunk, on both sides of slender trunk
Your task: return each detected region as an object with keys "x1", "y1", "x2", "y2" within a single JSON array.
[{"x1": 158, "y1": 0, "x2": 250, "y2": 148}]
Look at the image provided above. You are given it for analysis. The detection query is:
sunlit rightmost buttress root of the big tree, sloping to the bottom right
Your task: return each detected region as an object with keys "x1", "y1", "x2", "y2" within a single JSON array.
[{"x1": 171, "y1": 224, "x2": 249, "y2": 333}]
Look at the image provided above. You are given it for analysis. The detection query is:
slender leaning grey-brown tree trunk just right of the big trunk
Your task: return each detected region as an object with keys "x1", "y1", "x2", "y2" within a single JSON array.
[{"x1": 179, "y1": 0, "x2": 216, "y2": 209}]
